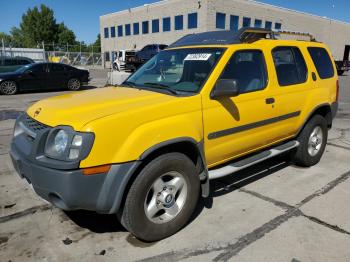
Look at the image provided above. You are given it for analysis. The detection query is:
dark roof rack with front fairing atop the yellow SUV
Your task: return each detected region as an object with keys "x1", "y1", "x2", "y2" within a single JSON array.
[{"x1": 169, "y1": 27, "x2": 316, "y2": 48}]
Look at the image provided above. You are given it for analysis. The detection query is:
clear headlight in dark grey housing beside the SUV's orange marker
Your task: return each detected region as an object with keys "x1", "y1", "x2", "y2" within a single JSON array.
[{"x1": 45, "y1": 126, "x2": 94, "y2": 161}]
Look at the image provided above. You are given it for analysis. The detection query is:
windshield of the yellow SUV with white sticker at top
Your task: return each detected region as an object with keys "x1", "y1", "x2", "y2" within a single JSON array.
[{"x1": 124, "y1": 48, "x2": 224, "y2": 93}]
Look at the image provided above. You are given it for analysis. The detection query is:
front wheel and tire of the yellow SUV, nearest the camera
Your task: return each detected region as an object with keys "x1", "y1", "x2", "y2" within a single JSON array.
[{"x1": 121, "y1": 153, "x2": 200, "y2": 242}]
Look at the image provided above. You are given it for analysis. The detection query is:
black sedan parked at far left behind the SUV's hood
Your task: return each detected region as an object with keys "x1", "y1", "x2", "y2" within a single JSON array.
[{"x1": 0, "y1": 63, "x2": 90, "y2": 95}]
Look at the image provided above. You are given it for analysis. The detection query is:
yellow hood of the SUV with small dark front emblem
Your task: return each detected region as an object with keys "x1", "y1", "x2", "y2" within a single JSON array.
[{"x1": 27, "y1": 87, "x2": 177, "y2": 131}]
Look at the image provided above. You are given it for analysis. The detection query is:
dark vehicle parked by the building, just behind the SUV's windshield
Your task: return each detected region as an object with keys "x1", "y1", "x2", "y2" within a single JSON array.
[{"x1": 125, "y1": 44, "x2": 168, "y2": 71}]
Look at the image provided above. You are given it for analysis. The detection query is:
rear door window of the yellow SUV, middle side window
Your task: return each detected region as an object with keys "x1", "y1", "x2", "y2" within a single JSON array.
[{"x1": 272, "y1": 47, "x2": 307, "y2": 86}]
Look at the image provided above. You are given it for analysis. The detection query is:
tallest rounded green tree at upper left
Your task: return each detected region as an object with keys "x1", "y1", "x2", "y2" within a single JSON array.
[{"x1": 20, "y1": 5, "x2": 58, "y2": 47}]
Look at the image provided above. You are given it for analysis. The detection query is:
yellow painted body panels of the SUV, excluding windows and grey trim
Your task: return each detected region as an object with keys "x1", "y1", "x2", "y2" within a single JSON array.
[{"x1": 27, "y1": 40, "x2": 338, "y2": 168}]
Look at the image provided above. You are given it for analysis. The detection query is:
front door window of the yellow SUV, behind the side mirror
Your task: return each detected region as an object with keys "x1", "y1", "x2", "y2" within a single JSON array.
[{"x1": 220, "y1": 50, "x2": 267, "y2": 94}]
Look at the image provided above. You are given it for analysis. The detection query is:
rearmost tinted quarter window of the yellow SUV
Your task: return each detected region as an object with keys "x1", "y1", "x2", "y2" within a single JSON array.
[{"x1": 308, "y1": 47, "x2": 334, "y2": 79}]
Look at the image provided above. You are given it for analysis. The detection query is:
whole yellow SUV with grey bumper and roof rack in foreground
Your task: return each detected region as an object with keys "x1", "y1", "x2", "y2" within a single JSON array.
[{"x1": 11, "y1": 28, "x2": 339, "y2": 241}]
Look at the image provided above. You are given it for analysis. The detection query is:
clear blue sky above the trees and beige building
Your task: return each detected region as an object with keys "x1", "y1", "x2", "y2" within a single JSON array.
[{"x1": 0, "y1": 0, "x2": 350, "y2": 43}]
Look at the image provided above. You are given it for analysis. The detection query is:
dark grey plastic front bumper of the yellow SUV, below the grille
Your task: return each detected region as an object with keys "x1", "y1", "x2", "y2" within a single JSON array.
[{"x1": 10, "y1": 144, "x2": 138, "y2": 214}]
